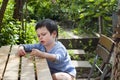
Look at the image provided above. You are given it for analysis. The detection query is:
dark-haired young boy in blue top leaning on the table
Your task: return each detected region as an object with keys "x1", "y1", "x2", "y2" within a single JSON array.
[{"x1": 18, "y1": 19, "x2": 76, "y2": 80}]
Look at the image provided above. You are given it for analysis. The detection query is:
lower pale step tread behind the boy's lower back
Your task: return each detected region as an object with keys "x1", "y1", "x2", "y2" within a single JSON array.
[{"x1": 72, "y1": 60, "x2": 92, "y2": 68}]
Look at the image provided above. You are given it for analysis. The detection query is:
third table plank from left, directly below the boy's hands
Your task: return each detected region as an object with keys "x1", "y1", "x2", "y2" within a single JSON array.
[{"x1": 20, "y1": 57, "x2": 35, "y2": 80}]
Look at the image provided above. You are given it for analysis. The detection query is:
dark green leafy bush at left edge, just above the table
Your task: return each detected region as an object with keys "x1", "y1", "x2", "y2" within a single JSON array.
[{"x1": 0, "y1": 21, "x2": 20, "y2": 45}]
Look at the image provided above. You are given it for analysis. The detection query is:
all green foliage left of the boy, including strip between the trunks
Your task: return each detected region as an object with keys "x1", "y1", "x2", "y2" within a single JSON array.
[{"x1": 0, "y1": 0, "x2": 38, "y2": 46}]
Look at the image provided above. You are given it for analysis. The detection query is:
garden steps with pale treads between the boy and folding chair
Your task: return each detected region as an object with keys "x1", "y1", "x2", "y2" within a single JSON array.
[{"x1": 58, "y1": 37, "x2": 99, "y2": 78}]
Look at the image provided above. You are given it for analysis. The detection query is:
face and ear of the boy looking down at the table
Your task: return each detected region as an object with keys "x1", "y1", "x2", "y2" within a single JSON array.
[{"x1": 36, "y1": 27, "x2": 56, "y2": 46}]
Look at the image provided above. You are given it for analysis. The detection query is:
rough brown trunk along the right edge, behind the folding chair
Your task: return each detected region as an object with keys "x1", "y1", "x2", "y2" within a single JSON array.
[{"x1": 111, "y1": 0, "x2": 120, "y2": 80}]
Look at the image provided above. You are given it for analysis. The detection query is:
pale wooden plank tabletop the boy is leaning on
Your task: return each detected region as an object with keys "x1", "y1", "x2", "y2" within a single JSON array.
[{"x1": 0, "y1": 45, "x2": 52, "y2": 80}]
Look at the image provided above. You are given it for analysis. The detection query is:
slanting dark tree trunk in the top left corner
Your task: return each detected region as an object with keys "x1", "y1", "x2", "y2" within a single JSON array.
[{"x1": 0, "y1": 0, "x2": 9, "y2": 32}]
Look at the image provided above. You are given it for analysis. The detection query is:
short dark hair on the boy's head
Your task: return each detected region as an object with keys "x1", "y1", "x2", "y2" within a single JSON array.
[{"x1": 35, "y1": 19, "x2": 58, "y2": 37}]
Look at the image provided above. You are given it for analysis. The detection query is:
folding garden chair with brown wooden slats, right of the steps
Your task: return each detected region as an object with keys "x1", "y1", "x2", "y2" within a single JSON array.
[{"x1": 88, "y1": 34, "x2": 115, "y2": 80}]
